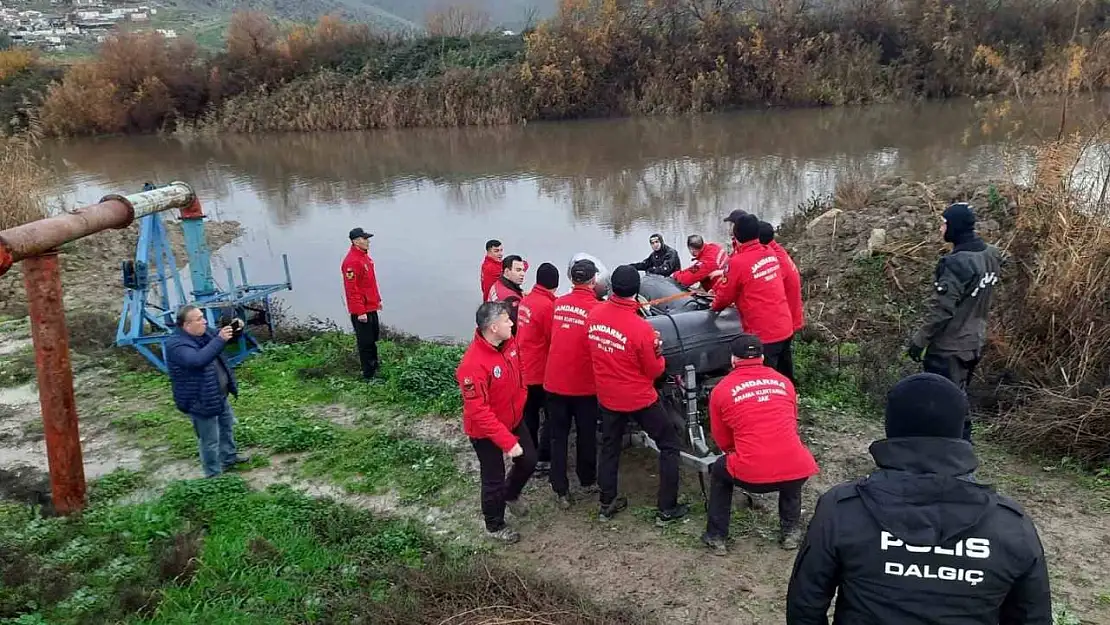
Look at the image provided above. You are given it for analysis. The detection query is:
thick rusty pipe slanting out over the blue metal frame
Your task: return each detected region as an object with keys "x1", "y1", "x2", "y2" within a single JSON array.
[{"x1": 0, "y1": 182, "x2": 195, "y2": 275}]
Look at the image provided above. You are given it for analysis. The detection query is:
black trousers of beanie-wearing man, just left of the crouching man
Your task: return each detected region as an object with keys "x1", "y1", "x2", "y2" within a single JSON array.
[{"x1": 597, "y1": 400, "x2": 682, "y2": 511}]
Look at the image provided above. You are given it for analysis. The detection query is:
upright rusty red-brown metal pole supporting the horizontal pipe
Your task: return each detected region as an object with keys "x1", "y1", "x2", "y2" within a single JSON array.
[{"x1": 23, "y1": 252, "x2": 84, "y2": 514}]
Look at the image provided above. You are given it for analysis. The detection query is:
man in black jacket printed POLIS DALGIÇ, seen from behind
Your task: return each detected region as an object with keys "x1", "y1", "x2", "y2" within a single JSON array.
[{"x1": 786, "y1": 373, "x2": 1052, "y2": 625}]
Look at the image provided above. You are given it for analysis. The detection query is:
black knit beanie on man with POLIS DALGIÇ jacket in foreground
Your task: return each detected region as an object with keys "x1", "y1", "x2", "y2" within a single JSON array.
[{"x1": 886, "y1": 373, "x2": 969, "y2": 438}]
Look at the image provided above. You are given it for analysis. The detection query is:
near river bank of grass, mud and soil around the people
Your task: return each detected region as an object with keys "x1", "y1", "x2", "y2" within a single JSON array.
[{"x1": 0, "y1": 173, "x2": 1110, "y2": 625}]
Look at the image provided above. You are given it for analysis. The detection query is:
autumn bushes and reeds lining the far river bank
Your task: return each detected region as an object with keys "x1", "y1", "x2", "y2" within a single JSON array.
[{"x1": 4, "y1": 0, "x2": 1110, "y2": 134}]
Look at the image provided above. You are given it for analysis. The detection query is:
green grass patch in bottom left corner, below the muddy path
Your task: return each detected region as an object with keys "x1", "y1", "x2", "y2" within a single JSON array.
[{"x1": 0, "y1": 474, "x2": 435, "y2": 625}]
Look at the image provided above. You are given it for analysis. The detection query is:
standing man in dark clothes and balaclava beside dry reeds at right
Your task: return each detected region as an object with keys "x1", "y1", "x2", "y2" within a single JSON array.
[{"x1": 908, "y1": 202, "x2": 1002, "y2": 441}]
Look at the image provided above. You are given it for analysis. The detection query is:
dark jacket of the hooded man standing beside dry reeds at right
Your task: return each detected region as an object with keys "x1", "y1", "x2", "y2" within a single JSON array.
[{"x1": 914, "y1": 228, "x2": 1002, "y2": 361}]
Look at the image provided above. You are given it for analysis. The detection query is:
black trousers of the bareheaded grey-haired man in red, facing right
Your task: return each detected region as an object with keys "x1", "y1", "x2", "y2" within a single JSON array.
[{"x1": 471, "y1": 421, "x2": 536, "y2": 532}]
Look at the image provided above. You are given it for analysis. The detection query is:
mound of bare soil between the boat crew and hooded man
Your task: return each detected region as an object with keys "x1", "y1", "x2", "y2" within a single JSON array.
[{"x1": 776, "y1": 177, "x2": 1016, "y2": 402}]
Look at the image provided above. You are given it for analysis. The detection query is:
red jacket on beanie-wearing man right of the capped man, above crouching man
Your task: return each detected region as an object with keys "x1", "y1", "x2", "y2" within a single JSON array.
[{"x1": 586, "y1": 296, "x2": 666, "y2": 412}]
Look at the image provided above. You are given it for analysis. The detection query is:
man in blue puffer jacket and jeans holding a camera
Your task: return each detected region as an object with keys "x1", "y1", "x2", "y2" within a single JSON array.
[{"x1": 165, "y1": 306, "x2": 246, "y2": 477}]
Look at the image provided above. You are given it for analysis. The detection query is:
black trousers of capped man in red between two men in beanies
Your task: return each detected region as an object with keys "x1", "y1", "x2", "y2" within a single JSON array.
[{"x1": 547, "y1": 393, "x2": 598, "y2": 495}]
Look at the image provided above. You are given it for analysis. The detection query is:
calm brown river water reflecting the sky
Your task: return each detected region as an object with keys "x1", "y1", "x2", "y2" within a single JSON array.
[{"x1": 43, "y1": 101, "x2": 1087, "y2": 339}]
